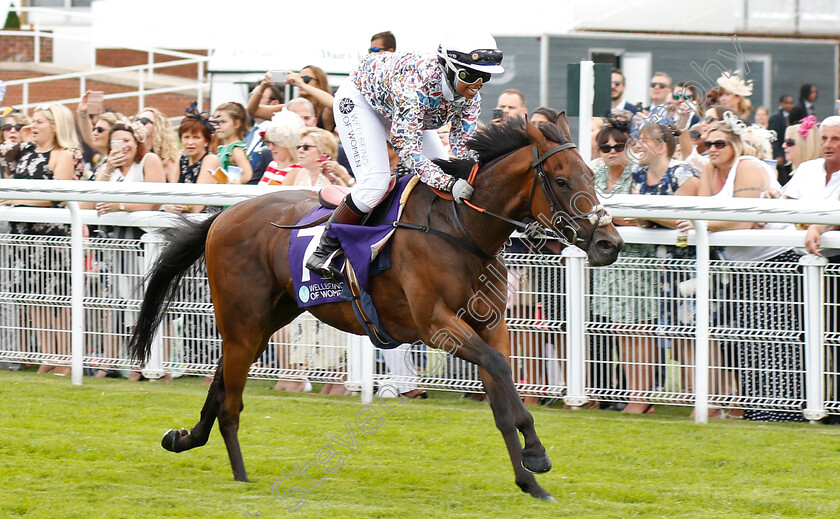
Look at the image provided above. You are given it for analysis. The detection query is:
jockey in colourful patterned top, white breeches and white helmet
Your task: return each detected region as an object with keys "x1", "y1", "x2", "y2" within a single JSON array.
[{"x1": 306, "y1": 34, "x2": 504, "y2": 279}]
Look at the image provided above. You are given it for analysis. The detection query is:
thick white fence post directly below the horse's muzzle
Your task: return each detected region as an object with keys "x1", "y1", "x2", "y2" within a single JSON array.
[{"x1": 563, "y1": 247, "x2": 589, "y2": 407}]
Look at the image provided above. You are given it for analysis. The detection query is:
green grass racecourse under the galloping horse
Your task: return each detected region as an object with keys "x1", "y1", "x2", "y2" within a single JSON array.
[{"x1": 0, "y1": 371, "x2": 840, "y2": 519}]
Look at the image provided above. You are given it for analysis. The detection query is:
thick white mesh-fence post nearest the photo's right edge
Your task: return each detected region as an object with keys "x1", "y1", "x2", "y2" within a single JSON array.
[{"x1": 799, "y1": 254, "x2": 828, "y2": 422}]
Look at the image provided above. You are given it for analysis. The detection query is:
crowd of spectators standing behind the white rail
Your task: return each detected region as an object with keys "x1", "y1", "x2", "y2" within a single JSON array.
[{"x1": 0, "y1": 32, "x2": 840, "y2": 421}]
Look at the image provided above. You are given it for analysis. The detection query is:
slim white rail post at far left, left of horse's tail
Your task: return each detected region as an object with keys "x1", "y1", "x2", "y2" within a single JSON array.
[{"x1": 67, "y1": 202, "x2": 85, "y2": 386}]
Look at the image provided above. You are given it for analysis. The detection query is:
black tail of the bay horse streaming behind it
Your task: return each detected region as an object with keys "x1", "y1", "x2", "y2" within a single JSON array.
[{"x1": 128, "y1": 213, "x2": 221, "y2": 362}]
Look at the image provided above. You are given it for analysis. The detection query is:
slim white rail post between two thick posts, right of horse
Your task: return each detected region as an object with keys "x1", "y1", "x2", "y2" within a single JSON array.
[{"x1": 689, "y1": 220, "x2": 710, "y2": 423}]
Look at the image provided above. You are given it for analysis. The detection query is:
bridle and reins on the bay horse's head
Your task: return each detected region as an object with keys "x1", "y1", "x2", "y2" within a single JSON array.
[{"x1": 456, "y1": 142, "x2": 612, "y2": 250}]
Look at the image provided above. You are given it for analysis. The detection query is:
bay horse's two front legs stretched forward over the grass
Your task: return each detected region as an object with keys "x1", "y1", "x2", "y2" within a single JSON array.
[{"x1": 428, "y1": 309, "x2": 554, "y2": 501}]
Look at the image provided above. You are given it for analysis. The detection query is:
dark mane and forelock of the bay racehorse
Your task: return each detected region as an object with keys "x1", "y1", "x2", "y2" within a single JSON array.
[{"x1": 434, "y1": 117, "x2": 568, "y2": 179}]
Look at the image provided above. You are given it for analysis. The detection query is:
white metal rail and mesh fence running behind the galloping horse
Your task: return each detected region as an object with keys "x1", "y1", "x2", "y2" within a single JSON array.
[{"x1": 0, "y1": 181, "x2": 840, "y2": 419}]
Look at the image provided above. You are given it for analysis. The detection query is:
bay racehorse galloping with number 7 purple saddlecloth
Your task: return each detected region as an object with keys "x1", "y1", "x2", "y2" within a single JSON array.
[{"x1": 129, "y1": 114, "x2": 624, "y2": 501}]
